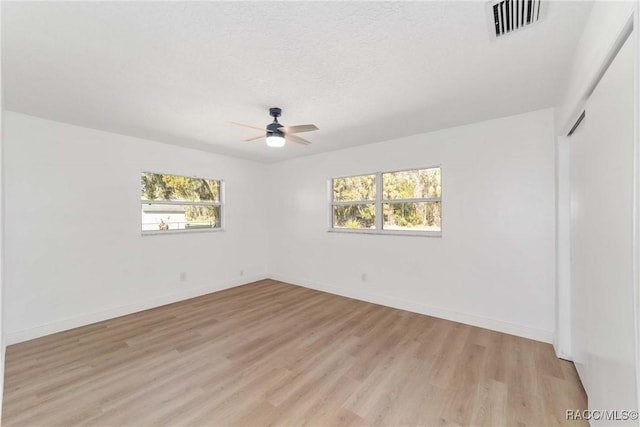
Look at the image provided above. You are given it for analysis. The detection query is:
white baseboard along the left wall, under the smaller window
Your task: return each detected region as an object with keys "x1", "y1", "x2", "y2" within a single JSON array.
[{"x1": 6, "y1": 275, "x2": 268, "y2": 345}]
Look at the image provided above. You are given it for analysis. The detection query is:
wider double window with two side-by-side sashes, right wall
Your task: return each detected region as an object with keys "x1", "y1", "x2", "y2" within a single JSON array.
[{"x1": 331, "y1": 167, "x2": 442, "y2": 235}]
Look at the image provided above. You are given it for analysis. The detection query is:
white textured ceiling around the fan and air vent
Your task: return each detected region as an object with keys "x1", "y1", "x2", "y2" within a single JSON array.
[{"x1": 2, "y1": 1, "x2": 591, "y2": 162}]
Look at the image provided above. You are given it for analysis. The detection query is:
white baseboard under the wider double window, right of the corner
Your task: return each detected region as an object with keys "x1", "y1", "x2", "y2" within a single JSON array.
[{"x1": 270, "y1": 274, "x2": 553, "y2": 344}]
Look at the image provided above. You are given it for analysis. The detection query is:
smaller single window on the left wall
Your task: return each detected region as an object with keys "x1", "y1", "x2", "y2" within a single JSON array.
[{"x1": 140, "y1": 172, "x2": 222, "y2": 233}]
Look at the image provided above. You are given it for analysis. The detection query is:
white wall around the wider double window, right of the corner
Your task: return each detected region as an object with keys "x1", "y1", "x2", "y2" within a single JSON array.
[{"x1": 269, "y1": 110, "x2": 555, "y2": 342}]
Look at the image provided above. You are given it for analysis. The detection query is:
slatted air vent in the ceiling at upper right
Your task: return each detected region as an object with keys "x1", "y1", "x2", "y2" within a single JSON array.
[{"x1": 488, "y1": 0, "x2": 543, "y2": 38}]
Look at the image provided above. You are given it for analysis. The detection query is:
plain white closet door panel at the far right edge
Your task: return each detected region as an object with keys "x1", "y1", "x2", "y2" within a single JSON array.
[{"x1": 568, "y1": 38, "x2": 638, "y2": 425}]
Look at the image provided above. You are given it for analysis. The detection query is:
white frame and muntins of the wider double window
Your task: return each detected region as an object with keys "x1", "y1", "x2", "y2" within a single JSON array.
[{"x1": 327, "y1": 165, "x2": 444, "y2": 237}]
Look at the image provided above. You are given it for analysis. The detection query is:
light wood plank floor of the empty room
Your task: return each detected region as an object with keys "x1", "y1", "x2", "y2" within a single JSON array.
[{"x1": 2, "y1": 280, "x2": 586, "y2": 427}]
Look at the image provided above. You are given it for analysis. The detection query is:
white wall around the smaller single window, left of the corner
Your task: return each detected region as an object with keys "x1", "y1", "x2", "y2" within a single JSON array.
[{"x1": 4, "y1": 112, "x2": 267, "y2": 344}]
